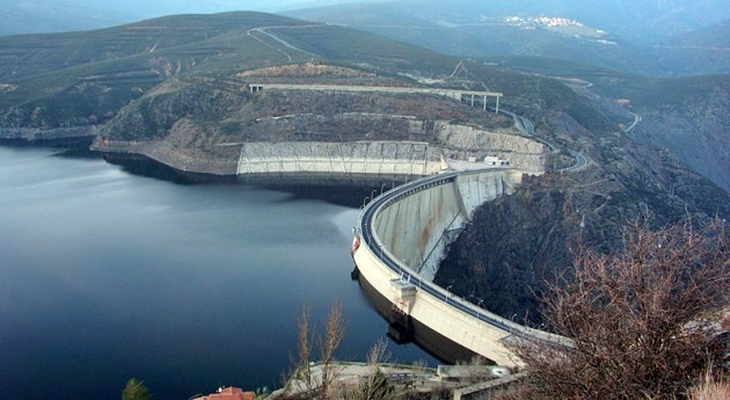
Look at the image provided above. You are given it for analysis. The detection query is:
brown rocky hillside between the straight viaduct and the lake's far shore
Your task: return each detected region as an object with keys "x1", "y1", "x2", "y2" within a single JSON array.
[{"x1": 93, "y1": 81, "x2": 548, "y2": 175}]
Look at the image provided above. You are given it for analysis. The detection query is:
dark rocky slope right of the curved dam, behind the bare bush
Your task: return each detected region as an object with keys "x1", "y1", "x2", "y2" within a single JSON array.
[{"x1": 435, "y1": 108, "x2": 730, "y2": 324}]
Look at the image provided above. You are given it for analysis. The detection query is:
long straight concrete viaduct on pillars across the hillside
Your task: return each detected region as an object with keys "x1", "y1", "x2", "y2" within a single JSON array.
[{"x1": 248, "y1": 83, "x2": 503, "y2": 112}]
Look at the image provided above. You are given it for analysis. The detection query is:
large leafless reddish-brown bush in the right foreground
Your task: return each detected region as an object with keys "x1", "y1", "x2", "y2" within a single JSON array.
[{"x1": 511, "y1": 220, "x2": 730, "y2": 399}]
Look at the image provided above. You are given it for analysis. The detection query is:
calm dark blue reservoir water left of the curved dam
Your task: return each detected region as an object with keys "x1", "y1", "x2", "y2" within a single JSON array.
[{"x1": 0, "y1": 146, "x2": 437, "y2": 400}]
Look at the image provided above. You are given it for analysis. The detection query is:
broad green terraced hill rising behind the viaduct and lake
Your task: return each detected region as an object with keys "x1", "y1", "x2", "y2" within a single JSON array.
[{"x1": 0, "y1": 12, "x2": 612, "y2": 136}]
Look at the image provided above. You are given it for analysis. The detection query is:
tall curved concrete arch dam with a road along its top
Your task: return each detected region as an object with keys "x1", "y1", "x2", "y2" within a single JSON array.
[{"x1": 352, "y1": 169, "x2": 569, "y2": 366}]
